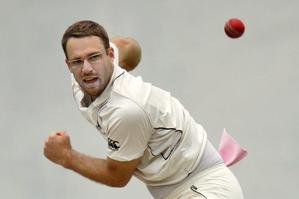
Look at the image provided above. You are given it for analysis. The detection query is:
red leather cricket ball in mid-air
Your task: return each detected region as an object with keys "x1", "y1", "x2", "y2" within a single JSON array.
[{"x1": 224, "y1": 18, "x2": 245, "y2": 39}]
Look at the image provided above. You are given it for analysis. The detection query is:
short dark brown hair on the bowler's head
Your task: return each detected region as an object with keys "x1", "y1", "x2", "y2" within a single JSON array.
[{"x1": 61, "y1": 20, "x2": 110, "y2": 58}]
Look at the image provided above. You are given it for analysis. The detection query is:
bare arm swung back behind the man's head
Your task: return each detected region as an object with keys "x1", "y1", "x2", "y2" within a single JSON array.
[{"x1": 111, "y1": 37, "x2": 141, "y2": 71}]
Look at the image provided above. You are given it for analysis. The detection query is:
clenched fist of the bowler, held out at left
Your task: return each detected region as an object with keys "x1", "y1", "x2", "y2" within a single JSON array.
[{"x1": 44, "y1": 131, "x2": 72, "y2": 168}]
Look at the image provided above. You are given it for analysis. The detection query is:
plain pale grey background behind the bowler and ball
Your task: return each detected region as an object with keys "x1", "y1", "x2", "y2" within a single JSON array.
[{"x1": 0, "y1": 0, "x2": 299, "y2": 199}]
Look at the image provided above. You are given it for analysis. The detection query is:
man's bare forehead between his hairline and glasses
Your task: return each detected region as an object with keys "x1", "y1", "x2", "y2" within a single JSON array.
[{"x1": 66, "y1": 36, "x2": 105, "y2": 59}]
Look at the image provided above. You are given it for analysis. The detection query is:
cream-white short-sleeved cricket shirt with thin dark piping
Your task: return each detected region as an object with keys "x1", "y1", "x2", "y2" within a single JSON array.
[{"x1": 72, "y1": 65, "x2": 207, "y2": 186}]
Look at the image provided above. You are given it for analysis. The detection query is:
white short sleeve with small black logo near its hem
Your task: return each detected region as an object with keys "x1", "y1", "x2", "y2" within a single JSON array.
[{"x1": 107, "y1": 102, "x2": 152, "y2": 161}]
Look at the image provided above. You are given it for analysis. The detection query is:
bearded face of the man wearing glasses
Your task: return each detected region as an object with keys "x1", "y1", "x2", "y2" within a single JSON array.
[{"x1": 66, "y1": 36, "x2": 114, "y2": 99}]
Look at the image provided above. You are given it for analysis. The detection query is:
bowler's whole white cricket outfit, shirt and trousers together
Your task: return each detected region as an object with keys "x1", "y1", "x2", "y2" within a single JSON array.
[{"x1": 72, "y1": 43, "x2": 242, "y2": 199}]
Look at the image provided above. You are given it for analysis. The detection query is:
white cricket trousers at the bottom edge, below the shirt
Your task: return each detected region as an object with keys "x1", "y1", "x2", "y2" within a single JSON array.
[{"x1": 165, "y1": 164, "x2": 244, "y2": 199}]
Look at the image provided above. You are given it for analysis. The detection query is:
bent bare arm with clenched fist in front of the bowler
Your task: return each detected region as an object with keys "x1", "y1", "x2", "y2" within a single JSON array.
[{"x1": 44, "y1": 132, "x2": 140, "y2": 187}]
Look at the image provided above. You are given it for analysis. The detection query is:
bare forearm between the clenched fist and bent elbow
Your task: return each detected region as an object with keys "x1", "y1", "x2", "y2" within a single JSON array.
[{"x1": 64, "y1": 150, "x2": 125, "y2": 187}]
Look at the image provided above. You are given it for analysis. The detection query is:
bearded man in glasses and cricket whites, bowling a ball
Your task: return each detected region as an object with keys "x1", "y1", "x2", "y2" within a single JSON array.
[{"x1": 44, "y1": 21, "x2": 243, "y2": 199}]
